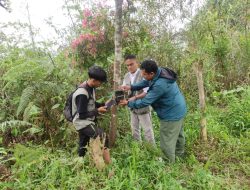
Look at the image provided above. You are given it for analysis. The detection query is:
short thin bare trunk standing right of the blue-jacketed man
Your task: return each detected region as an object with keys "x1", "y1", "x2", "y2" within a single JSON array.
[{"x1": 194, "y1": 62, "x2": 207, "y2": 142}]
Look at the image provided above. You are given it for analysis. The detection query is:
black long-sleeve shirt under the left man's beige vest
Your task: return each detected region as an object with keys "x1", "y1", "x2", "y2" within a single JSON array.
[{"x1": 76, "y1": 86, "x2": 105, "y2": 119}]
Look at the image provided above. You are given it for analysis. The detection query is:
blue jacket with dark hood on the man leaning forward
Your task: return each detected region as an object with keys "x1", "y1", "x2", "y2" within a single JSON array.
[{"x1": 128, "y1": 68, "x2": 187, "y2": 121}]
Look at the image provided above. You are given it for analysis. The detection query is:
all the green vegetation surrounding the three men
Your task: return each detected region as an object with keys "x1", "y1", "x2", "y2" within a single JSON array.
[{"x1": 0, "y1": 0, "x2": 250, "y2": 190}]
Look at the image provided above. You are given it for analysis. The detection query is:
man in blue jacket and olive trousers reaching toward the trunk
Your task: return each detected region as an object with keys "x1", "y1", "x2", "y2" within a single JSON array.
[{"x1": 120, "y1": 60, "x2": 187, "y2": 163}]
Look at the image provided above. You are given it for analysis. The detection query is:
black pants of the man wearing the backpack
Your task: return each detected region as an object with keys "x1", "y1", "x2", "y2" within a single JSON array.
[{"x1": 78, "y1": 125, "x2": 108, "y2": 156}]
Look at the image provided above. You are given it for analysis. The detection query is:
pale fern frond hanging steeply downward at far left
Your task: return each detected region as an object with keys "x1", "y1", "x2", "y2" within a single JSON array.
[{"x1": 17, "y1": 86, "x2": 35, "y2": 116}]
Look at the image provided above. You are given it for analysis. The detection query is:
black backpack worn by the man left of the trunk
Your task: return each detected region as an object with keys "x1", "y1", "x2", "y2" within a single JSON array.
[{"x1": 63, "y1": 85, "x2": 88, "y2": 122}]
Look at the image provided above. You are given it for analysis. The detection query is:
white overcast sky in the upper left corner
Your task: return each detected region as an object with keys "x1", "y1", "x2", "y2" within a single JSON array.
[{"x1": 0, "y1": 0, "x2": 70, "y2": 43}]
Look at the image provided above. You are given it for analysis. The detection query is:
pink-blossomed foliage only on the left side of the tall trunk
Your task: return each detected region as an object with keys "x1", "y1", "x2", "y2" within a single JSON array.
[{"x1": 70, "y1": 4, "x2": 114, "y2": 68}]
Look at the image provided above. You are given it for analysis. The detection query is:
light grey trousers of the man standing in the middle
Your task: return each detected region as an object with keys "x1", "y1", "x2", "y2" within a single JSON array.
[{"x1": 130, "y1": 111, "x2": 155, "y2": 145}]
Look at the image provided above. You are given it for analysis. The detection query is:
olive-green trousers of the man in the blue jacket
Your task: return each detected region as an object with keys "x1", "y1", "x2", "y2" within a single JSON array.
[{"x1": 160, "y1": 119, "x2": 185, "y2": 163}]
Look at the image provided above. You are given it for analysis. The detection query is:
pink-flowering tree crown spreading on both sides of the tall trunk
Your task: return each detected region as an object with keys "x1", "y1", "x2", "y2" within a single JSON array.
[{"x1": 66, "y1": 0, "x2": 153, "y2": 70}]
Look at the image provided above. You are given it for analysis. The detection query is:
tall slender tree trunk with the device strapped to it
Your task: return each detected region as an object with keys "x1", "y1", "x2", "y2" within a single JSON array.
[{"x1": 109, "y1": 0, "x2": 123, "y2": 147}]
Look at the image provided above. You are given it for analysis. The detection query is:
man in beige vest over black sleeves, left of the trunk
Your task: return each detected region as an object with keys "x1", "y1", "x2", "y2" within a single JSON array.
[{"x1": 72, "y1": 66, "x2": 110, "y2": 163}]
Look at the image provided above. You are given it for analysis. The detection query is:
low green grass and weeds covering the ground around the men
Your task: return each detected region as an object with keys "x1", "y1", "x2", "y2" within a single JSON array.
[{"x1": 0, "y1": 87, "x2": 250, "y2": 190}]
